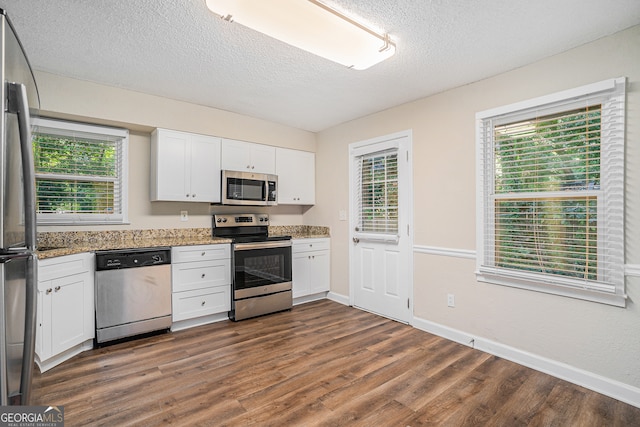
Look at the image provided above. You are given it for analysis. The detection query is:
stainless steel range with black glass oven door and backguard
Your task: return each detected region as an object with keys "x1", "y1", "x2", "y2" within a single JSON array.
[{"x1": 213, "y1": 214, "x2": 293, "y2": 320}]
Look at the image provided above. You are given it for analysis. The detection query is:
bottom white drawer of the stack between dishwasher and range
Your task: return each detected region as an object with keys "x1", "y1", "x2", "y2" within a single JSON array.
[{"x1": 173, "y1": 285, "x2": 231, "y2": 322}]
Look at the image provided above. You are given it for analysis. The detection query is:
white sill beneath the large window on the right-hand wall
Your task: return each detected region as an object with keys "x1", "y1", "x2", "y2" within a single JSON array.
[{"x1": 476, "y1": 270, "x2": 627, "y2": 308}]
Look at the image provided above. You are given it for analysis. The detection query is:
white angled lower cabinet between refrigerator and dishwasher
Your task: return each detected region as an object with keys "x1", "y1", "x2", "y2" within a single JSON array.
[{"x1": 36, "y1": 253, "x2": 95, "y2": 372}]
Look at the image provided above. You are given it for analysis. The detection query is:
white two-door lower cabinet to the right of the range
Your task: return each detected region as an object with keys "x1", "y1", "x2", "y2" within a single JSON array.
[{"x1": 291, "y1": 238, "x2": 330, "y2": 298}]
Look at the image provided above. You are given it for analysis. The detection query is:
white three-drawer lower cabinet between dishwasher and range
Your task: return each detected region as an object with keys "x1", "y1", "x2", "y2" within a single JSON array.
[{"x1": 171, "y1": 244, "x2": 231, "y2": 330}]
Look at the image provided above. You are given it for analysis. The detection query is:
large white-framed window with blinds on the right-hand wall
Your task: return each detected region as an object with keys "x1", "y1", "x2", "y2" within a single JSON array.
[{"x1": 476, "y1": 78, "x2": 625, "y2": 306}]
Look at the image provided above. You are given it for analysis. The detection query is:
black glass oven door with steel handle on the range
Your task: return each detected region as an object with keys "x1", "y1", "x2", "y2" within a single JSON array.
[{"x1": 233, "y1": 240, "x2": 291, "y2": 300}]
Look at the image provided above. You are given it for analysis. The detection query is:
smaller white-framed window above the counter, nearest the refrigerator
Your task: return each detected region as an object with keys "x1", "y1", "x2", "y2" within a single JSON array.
[{"x1": 33, "y1": 119, "x2": 129, "y2": 224}]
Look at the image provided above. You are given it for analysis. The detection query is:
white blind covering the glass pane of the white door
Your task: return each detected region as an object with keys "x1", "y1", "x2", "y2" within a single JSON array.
[{"x1": 356, "y1": 149, "x2": 398, "y2": 235}]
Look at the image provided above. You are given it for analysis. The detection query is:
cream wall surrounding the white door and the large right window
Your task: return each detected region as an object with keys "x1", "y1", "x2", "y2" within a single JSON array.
[{"x1": 304, "y1": 26, "x2": 640, "y2": 405}]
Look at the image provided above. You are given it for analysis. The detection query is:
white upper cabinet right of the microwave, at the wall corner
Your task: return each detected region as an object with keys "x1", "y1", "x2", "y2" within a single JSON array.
[{"x1": 276, "y1": 148, "x2": 316, "y2": 205}]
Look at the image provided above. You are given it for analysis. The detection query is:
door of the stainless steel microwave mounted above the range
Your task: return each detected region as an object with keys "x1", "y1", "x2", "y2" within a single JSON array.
[{"x1": 222, "y1": 171, "x2": 267, "y2": 206}]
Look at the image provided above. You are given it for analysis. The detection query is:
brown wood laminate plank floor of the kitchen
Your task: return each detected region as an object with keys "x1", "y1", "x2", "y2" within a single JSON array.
[{"x1": 33, "y1": 300, "x2": 640, "y2": 427}]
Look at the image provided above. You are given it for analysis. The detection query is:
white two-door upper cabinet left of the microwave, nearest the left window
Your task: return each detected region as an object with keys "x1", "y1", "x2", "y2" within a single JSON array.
[{"x1": 150, "y1": 129, "x2": 221, "y2": 203}]
